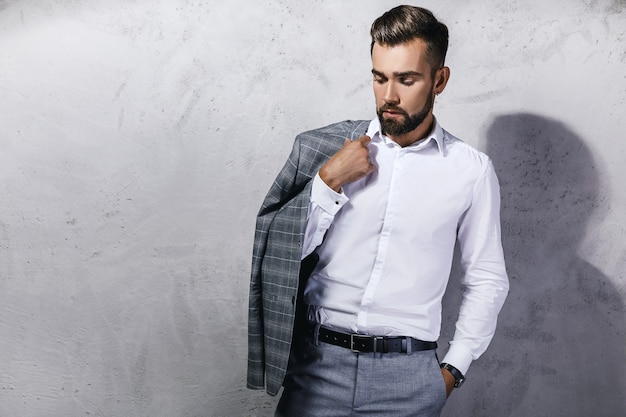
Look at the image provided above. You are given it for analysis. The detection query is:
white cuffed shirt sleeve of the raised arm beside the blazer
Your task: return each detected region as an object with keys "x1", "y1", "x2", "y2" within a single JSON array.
[{"x1": 302, "y1": 173, "x2": 348, "y2": 259}]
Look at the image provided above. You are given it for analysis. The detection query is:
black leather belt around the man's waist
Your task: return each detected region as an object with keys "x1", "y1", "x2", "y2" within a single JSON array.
[{"x1": 306, "y1": 323, "x2": 437, "y2": 353}]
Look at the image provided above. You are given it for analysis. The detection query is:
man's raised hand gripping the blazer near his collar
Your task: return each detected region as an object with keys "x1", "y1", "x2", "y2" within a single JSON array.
[{"x1": 320, "y1": 136, "x2": 376, "y2": 192}]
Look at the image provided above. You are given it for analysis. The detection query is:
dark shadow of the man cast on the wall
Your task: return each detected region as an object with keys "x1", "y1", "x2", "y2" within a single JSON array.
[{"x1": 443, "y1": 114, "x2": 626, "y2": 417}]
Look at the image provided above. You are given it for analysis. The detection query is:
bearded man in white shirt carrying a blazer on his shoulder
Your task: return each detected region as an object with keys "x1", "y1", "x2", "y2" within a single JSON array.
[{"x1": 248, "y1": 6, "x2": 508, "y2": 417}]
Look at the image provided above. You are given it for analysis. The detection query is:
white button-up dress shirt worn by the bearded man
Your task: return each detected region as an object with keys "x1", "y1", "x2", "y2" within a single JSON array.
[{"x1": 302, "y1": 119, "x2": 508, "y2": 373}]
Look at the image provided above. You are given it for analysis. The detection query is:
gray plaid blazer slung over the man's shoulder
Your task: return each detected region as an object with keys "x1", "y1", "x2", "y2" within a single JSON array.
[{"x1": 247, "y1": 120, "x2": 369, "y2": 395}]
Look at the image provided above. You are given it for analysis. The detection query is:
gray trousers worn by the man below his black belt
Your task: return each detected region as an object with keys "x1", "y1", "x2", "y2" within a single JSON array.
[{"x1": 275, "y1": 326, "x2": 446, "y2": 417}]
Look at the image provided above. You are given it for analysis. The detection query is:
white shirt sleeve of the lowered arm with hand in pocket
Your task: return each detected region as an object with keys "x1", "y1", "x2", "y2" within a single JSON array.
[{"x1": 443, "y1": 160, "x2": 509, "y2": 374}]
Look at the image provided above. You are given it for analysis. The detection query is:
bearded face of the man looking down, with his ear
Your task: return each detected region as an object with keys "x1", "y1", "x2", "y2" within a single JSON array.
[{"x1": 372, "y1": 39, "x2": 449, "y2": 144}]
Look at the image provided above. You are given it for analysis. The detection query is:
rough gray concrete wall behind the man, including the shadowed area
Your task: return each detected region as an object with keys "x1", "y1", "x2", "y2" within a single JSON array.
[{"x1": 0, "y1": 0, "x2": 626, "y2": 417}]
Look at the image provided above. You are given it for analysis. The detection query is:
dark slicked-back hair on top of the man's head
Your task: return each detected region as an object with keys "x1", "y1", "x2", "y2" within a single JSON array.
[{"x1": 370, "y1": 6, "x2": 448, "y2": 72}]
